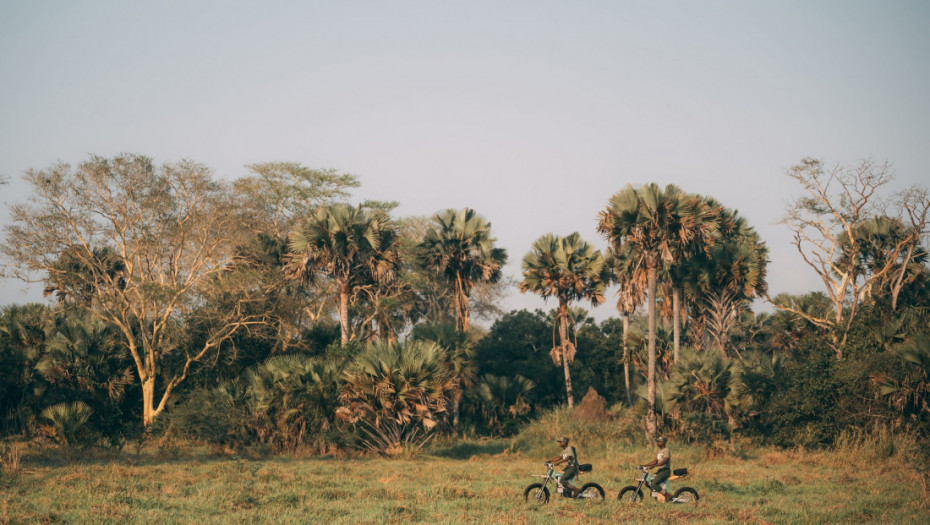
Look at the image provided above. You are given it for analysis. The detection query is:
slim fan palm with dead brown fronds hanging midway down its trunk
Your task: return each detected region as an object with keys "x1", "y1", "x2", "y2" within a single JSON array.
[{"x1": 519, "y1": 232, "x2": 610, "y2": 408}]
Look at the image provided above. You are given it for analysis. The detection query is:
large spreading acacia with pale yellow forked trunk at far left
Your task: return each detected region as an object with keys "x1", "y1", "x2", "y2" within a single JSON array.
[{"x1": 3, "y1": 155, "x2": 263, "y2": 426}]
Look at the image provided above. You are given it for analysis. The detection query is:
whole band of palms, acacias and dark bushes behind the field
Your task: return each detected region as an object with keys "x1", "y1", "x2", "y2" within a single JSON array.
[{"x1": 0, "y1": 155, "x2": 930, "y2": 454}]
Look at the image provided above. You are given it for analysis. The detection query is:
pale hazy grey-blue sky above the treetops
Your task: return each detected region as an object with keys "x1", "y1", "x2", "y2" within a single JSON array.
[{"x1": 0, "y1": 0, "x2": 930, "y2": 319}]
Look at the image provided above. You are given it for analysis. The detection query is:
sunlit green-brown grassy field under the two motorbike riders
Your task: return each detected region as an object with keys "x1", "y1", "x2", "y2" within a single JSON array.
[{"x1": 0, "y1": 440, "x2": 930, "y2": 524}]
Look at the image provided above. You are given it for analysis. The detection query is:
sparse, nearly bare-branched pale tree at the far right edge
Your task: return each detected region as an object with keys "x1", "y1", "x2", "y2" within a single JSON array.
[{"x1": 773, "y1": 158, "x2": 930, "y2": 358}]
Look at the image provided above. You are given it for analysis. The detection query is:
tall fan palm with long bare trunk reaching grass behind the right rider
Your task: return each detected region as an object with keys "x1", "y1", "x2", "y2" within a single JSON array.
[{"x1": 597, "y1": 184, "x2": 716, "y2": 440}]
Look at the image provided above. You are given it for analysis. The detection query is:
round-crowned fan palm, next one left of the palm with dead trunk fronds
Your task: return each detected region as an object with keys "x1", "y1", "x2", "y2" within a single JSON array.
[{"x1": 419, "y1": 208, "x2": 507, "y2": 332}]
